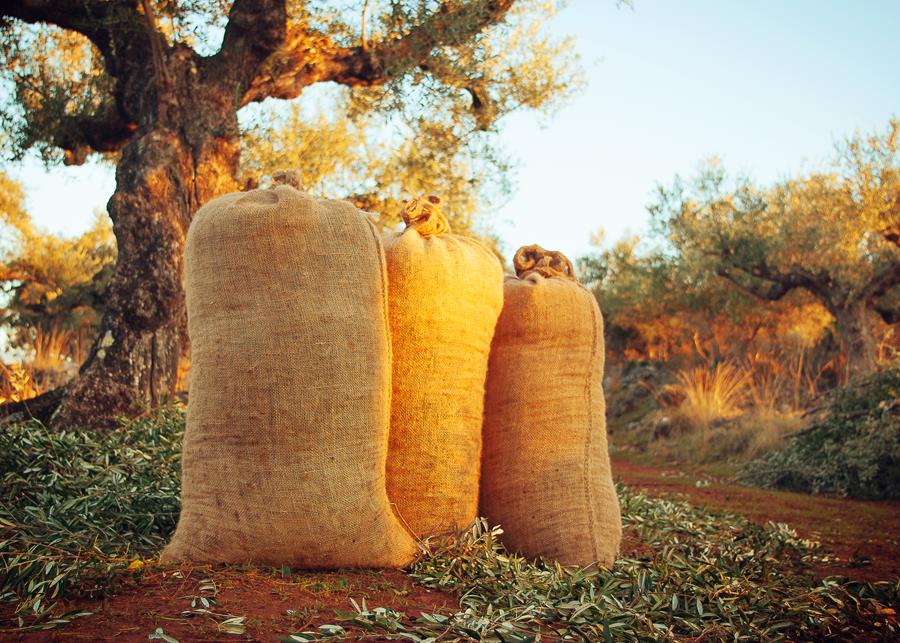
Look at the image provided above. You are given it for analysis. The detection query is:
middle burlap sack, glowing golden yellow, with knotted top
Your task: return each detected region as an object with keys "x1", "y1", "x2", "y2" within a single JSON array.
[{"x1": 384, "y1": 197, "x2": 503, "y2": 537}]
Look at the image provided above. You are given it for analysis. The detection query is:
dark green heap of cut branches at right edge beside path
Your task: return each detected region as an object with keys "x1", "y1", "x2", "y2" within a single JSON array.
[{"x1": 739, "y1": 366, "x2": 900, "y2": 499}]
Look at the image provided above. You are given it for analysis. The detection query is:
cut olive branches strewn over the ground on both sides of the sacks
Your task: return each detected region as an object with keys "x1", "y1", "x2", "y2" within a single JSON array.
[{"x1": 0, "y1": 408, "x2": 900, "y2": 641}]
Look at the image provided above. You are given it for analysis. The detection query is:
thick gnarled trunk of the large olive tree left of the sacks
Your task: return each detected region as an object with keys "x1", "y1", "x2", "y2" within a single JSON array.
[{"x1": 51, "y1": 87, "x2": 239, "y2": 427}]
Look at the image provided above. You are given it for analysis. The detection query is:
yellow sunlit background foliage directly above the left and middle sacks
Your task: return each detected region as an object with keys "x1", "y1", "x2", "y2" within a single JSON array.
[{"x1": 241, "y1": 88, "x2": 510, "y2": 236}]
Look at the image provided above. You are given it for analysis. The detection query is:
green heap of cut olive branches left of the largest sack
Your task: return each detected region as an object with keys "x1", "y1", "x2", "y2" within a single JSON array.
[{"x1": 0, "y1": 408, "x2": 184, "y2": 618}]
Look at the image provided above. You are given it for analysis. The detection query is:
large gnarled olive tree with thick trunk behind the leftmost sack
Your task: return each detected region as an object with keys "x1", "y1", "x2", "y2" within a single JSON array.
[{"x1": 0, "y1": 0, "x2": 574, "y2": 425}]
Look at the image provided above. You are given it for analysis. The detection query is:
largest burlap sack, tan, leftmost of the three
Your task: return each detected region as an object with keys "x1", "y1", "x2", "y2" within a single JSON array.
[{"x1": 163, "y1": 185, "x2": 415, "y2": 568}]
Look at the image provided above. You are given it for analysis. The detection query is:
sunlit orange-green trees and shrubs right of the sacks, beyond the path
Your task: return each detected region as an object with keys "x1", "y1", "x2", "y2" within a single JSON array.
[{"x1": 581, "y1": 121, "x2": 900, "y2": 388}]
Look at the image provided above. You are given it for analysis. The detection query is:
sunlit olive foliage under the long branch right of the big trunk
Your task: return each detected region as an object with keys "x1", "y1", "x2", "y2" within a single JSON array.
[{"x1": 242, "y1": 2, "x2": 581, "y2": 233}]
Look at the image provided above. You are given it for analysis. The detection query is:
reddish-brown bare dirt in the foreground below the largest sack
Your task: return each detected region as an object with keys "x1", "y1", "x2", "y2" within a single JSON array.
[{"x1": 0, "y1": 566, "x2": 459, "y2": 643}]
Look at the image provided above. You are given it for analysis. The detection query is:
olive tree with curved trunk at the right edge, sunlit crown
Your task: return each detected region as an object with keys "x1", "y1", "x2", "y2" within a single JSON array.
[{"x1": 650, "y1": 121, "x2": 900, "y2": 377}]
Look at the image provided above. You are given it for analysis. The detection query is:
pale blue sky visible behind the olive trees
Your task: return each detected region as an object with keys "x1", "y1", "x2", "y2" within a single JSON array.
[{"x1": 1, "y1": 0, "x2": 900, "y2": 258}]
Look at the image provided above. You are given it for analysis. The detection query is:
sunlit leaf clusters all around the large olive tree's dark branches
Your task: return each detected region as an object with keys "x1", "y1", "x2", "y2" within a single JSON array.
[{"x1": 0, "y1": 0, "x2": 581, "y2": 233}]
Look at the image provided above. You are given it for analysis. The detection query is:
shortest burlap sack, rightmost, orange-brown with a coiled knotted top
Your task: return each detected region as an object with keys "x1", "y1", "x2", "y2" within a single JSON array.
[{"x1": 480, "y1": 246, "x2": 622, "y2": 566}]
